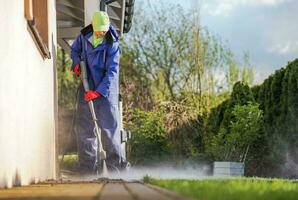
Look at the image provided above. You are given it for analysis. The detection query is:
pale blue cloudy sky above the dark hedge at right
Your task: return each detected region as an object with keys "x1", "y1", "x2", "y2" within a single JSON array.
[{"x1": 137, "y1": 0, "x2": 298, "y2": 82}]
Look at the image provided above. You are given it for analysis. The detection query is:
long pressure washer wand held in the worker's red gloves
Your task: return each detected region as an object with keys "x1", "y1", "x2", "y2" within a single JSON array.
[{"x1": 80, "y1": 61, "x2": 107, "y2": 164}]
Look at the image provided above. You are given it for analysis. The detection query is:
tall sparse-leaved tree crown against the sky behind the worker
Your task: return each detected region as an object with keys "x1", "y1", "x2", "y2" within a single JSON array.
[{"x1": 121, "y1": 2, "x2": 234, "y2": 112}]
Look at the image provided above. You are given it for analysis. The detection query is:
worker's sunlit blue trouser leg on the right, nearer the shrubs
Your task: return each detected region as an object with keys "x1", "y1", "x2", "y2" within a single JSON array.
[{"x1": 97, "y1": 97, "x2": 121, "y2": 170}]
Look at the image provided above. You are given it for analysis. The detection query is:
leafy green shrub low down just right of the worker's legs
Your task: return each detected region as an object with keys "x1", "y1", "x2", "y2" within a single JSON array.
[{"x1": 129, "y1": 109, "x2": 170, "y2": 165}]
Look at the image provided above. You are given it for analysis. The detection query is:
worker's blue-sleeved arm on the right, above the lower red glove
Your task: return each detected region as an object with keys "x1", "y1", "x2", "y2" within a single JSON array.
[{"x1": 96, "y1": 42, "x2": 120, "y2": 97}]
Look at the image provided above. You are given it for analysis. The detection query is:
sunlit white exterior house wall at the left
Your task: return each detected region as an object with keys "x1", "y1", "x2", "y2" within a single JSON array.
[{"x1": 0, "y1": 0, "x2": 56, "y2": 187}]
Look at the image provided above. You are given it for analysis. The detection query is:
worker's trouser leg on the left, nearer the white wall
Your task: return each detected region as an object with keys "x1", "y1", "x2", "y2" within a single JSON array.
[{"x1": 75, "y1": 87, "x2": 97, "y2": 173}]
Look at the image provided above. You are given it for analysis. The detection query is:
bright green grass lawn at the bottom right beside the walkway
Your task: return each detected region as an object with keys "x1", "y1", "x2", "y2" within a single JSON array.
[{"x1": 144, "y1": 177, "x2": 298, "y2": 200}]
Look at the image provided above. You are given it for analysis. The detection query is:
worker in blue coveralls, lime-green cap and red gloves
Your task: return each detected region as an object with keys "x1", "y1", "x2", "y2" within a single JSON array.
[{"x1": 71, "y1": 11, "x2": 126, "y2": 173}]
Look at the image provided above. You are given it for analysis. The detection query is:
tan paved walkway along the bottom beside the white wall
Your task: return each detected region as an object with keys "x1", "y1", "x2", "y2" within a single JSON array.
[{"x1": 0, "y1": 181, "x2": 186, "y2": 200}]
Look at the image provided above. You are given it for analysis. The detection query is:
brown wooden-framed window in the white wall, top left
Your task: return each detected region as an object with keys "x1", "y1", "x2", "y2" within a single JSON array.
[{"x1": 24, "y1": 0, "x2": 51, "y2": 59}]
